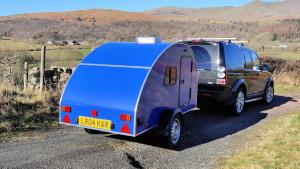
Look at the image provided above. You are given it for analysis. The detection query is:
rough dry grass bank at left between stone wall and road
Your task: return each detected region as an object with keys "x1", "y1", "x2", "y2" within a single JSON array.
[{"x1": 0, "y1": 85, "x2": 60, "y2": 141}]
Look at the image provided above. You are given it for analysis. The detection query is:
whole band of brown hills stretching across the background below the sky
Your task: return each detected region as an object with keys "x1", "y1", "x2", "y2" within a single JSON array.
[{"x1": 0, "y1": 0, "x2": 300, "y2": 44}]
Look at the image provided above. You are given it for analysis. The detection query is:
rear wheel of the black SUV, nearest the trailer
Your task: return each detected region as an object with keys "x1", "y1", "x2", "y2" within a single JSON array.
[{"x1": 231, "y1": 88, "x2": 245, "y2": 116}]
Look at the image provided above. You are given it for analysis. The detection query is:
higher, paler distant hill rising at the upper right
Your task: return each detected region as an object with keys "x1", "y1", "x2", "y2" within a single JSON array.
[{"x1": 145, "y1": 0, "x2": 300, "y2": 21}]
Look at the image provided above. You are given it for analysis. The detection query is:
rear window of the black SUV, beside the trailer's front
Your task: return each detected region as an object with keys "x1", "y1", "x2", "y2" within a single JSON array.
[{"x1": 192, "y1": 44, "x2": 220, "y2": 70}]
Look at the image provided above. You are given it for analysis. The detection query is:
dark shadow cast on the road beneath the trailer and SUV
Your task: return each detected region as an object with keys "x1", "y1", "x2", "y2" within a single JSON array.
[{"x1": 109, "y1": 96, "x2": 296, "y2": 150}]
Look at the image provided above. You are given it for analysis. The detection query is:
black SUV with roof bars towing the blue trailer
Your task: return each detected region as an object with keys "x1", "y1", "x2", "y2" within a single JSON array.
[{"x1": 185, "y1": 40, "x2": 274, "y2": 114}]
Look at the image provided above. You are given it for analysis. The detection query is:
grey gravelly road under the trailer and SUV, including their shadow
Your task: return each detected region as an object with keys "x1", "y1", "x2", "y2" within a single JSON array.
[{"x1": 0, "y1": 94, "x2": 300, "y2": 169}]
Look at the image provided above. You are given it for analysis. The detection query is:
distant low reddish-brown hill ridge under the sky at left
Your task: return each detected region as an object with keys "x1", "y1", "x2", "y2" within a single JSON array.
[{"x1": 0, "y1": 9, "x2": 160, "y2": 25}]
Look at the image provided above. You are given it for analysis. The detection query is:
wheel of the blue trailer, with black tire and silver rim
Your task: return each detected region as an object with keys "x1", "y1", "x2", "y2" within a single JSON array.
[{"x1": 165, "y1": 114, "x2": 183, "y2": 149}]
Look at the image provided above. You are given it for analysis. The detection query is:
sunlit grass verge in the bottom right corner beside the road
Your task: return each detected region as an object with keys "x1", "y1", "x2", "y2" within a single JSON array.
[{"x1": 218, "y1": 111, "x2": 300, "y2": 169}]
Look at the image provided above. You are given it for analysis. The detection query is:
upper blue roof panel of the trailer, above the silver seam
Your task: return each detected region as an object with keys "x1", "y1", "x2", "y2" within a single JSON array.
[{"x1": 81, "y1": 42, "x2": 171, "y2": 67}]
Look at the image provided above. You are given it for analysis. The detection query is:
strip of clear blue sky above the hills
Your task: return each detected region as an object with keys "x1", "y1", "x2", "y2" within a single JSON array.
[{"x1": 0, "y1": 0, "x2": 282, "y2": 16}]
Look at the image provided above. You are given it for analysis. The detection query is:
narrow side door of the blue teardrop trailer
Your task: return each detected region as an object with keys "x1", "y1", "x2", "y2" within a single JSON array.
[{"x1": 179, "y1": 56, "x2": 193, "y2": 107}]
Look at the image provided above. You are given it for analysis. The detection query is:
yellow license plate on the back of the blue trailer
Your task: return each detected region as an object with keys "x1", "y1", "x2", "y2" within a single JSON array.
[{"x1": 78, "y1": 116, "x2": 112, "y2": 130}]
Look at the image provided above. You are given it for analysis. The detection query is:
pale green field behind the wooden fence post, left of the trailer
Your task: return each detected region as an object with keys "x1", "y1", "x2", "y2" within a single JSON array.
[{"x1": 0, "y1": 40, "x2": 91, "y2": 67}]
